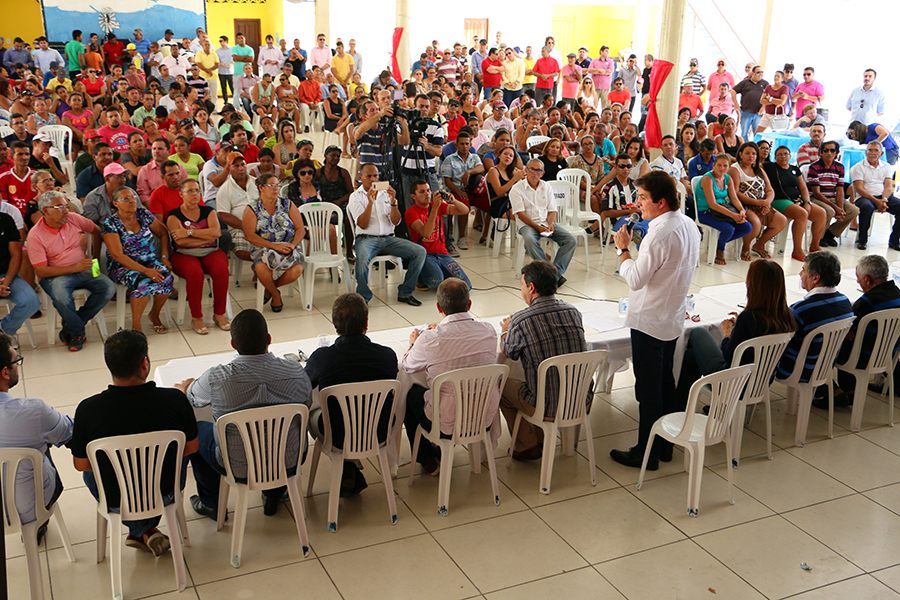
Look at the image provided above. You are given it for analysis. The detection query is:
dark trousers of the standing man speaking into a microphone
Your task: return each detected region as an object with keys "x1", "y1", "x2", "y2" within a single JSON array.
[{"x1": 631, "y1": 329, "x2": 678, "y2": 464}]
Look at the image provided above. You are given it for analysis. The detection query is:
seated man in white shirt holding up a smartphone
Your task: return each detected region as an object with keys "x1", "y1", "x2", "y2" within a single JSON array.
[{"x1": 347, "y1": 163, "x2": 425, "y2": 306}]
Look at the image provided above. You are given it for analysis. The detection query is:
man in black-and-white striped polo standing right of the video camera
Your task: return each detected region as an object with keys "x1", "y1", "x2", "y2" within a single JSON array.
[{"x1": 401, "y1": 94, "x2": 448, "y2": 245}]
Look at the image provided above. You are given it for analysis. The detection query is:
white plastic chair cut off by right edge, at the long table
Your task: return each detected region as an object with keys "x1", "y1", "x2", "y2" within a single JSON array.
[{"x1": 835, "y1": 308, "x2": 900, "y2": 431}]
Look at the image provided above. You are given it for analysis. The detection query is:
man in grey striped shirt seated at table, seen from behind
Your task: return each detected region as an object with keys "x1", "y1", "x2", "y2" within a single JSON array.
[{"x1": 175, "y1": 309, "x2": 312, "y2": 521}]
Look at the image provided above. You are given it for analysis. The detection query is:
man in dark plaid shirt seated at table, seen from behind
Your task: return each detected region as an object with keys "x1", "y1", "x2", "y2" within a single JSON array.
[{"x1": 500, "y1": 260, "x2": 593, "y2": 460}]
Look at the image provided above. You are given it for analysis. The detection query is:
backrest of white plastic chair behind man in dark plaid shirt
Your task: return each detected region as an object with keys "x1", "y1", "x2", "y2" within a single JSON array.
[{"x1": 534, "y1": 350, "x2": 609, "y2": 428}]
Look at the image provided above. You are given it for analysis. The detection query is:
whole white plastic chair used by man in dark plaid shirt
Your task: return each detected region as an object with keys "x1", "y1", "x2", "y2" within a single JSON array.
[{"x1": 506, "y1": 350, "x2": 609, "y2": 494}]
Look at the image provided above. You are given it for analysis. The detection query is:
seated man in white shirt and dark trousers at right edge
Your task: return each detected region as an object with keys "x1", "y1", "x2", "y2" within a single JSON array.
[{"x1": 850, "y1": 140, "x2": 900, "y2": 250}]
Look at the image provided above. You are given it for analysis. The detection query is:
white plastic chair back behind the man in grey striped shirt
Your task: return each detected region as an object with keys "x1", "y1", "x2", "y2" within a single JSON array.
[{"x1": 216, "y1": 404, "x2": 309, "y2": 490}]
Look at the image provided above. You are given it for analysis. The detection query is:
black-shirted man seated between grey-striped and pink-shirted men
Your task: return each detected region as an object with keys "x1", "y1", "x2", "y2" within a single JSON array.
[{"x1": 306, "y1": 294, "x2": 399, "y2": 498}]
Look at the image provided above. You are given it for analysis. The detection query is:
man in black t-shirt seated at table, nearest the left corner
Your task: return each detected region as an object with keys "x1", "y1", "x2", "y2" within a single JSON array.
[{"x1": 68, "y1": 329, "x2": 199, "y2": 556}]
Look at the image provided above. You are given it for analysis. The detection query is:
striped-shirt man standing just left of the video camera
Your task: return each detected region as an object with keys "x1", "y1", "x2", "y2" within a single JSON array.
[{"x1": 353, "y1": 90, "x2": 409, "y2": 181}]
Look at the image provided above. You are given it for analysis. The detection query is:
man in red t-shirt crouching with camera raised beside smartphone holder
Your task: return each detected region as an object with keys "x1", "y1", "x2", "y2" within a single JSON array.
[{"x1": 404, "y1": 179, "x2": 472, "y2": 289}]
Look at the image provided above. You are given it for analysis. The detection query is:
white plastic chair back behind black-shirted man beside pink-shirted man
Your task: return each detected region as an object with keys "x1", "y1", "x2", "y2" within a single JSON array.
[{"x1": 319, "y1": 379, "x2": 400, "y2": 460}]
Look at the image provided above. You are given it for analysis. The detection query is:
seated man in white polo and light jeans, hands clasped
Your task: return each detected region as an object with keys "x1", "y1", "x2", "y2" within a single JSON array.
[{"x1": 509, "y1": 158, "x2": 578, "y2": 287}]
